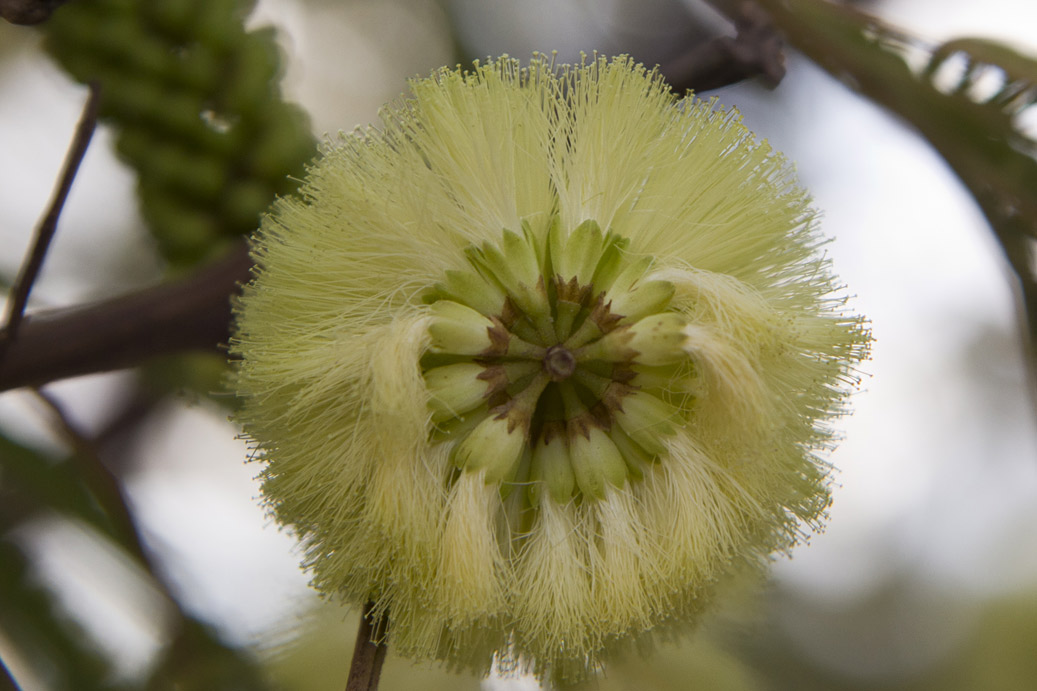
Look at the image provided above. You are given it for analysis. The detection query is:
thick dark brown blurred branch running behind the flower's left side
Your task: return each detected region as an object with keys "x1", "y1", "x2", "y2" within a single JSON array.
[{"x1": 0, "y1": 242, "x2": 252, "y2": 391}]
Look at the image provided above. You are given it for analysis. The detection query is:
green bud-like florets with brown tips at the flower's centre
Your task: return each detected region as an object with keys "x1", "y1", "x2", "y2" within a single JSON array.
[{"x1": 422, "y1": 219, "x2": 688, "y2": 504}]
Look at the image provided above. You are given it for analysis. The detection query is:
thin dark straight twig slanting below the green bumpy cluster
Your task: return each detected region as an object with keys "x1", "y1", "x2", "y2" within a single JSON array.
[{"x1": 0, "y1": 83, "x2": 101, "y2": 360}]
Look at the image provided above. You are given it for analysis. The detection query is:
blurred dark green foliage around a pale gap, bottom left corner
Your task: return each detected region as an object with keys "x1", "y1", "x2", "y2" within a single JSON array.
[{"x1": 0, "y1": 425, "x2": 277, "y2": 691}]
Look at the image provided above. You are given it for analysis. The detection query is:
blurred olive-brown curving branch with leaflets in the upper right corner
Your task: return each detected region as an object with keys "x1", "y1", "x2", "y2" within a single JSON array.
[{"x1": 710, "y1": 0, "x2": 1037, "y2": 393}]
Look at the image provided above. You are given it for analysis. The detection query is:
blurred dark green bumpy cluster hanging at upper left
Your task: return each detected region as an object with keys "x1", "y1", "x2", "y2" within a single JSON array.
[{"x1": 46, "y1": 0, "x2": 315, "y2": 267}]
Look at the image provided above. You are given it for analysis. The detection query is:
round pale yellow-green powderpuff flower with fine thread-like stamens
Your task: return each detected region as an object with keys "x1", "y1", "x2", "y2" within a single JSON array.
[{"x1": 233, "y1": 57, "x2": 868, "y2": 682}]
